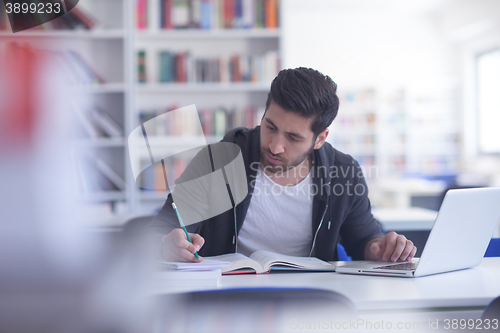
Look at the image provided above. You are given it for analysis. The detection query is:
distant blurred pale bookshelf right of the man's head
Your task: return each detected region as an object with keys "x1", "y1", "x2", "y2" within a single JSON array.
[{"x1": 329, "y1": 85, "x2": 461, "y2": 178}]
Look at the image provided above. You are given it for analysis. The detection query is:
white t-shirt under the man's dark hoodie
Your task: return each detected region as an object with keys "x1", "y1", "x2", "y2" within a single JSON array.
[{"x1": 238, "y1": 168, "x2": 314, "y2": 257}]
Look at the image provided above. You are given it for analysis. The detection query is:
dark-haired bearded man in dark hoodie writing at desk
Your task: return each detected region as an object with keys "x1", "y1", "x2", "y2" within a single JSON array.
[{"x1": 149, "y1": 68, "x2": 417, "y2": 262}]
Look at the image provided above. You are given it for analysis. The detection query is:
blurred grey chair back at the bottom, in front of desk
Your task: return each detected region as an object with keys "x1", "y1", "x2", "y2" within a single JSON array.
[{"x1": 154, "y1": 288, "x2": 357, "y2": 333}]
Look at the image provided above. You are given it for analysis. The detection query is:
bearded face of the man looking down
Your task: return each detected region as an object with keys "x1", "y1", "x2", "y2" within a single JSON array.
[{"x1": 260, "y1": 103, "x2": 328, "y2": 173}]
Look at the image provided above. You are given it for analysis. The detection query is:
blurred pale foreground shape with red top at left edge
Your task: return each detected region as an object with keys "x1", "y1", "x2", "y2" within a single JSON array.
[{"x1": 0, "y1": 41, "x2": 150, "y2": 332}]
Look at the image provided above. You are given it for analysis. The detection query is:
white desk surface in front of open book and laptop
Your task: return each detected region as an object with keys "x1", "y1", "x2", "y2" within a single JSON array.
[{"x1": 161, "y1": 257, "x2": 500, "y2": 310}]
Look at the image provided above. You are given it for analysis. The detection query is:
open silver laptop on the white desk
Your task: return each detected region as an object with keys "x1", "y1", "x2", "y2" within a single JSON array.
[{"x1": 335, "y1": 187, "x2": 500, "y2": 277}]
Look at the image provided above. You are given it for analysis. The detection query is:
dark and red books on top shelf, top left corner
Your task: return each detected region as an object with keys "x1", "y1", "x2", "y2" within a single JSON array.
[{"x1": 0, "y1": 6, "x2": 100, "y2": 30}]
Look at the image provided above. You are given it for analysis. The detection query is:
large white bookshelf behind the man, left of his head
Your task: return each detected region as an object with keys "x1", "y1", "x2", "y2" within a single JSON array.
[{"x1": 0, "y1": 0, "x2": 281, "y2": 214}]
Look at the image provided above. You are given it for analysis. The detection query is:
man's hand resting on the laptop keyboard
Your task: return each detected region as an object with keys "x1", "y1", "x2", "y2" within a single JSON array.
[{"x1": 365, "y1": 231, "x2": 417, "y2": 262}]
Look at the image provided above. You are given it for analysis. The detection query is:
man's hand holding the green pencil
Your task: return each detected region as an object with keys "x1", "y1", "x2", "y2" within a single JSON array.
[{"x1": 161, "y1": 228, "x2": 205, "y2": 262}]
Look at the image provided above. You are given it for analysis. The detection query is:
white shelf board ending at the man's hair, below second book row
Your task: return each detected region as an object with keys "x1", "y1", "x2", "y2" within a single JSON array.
[{"x1": 136, "y1": 82, "x2": 271, "y2": 93}]
